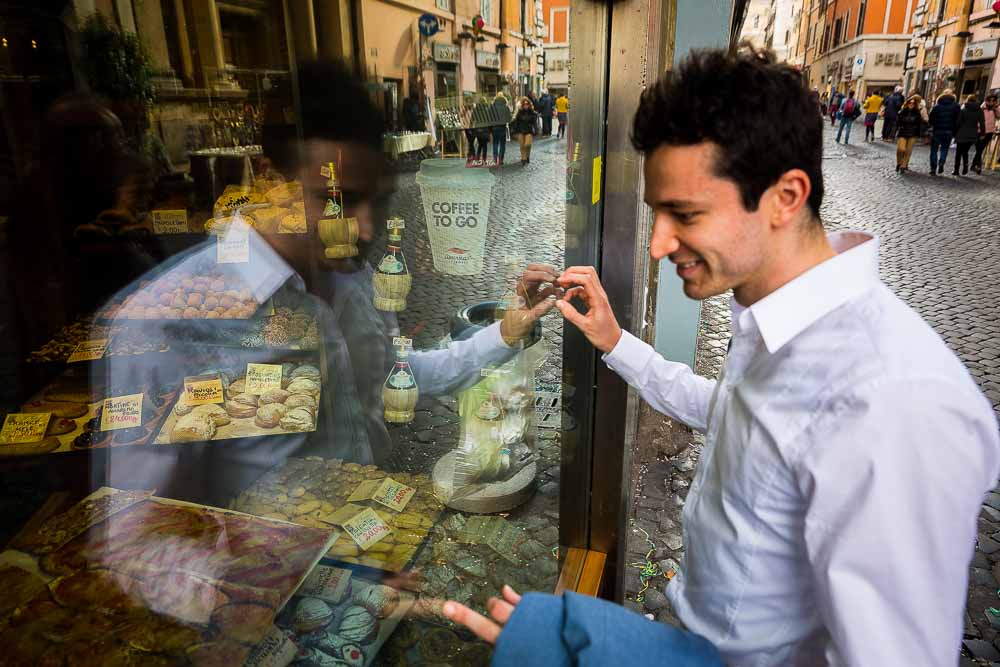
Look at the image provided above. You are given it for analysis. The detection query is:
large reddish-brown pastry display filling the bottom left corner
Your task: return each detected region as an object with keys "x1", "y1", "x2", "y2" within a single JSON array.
[{"x1": 0, "y1": 489, "x2": 334, "y2": 665}]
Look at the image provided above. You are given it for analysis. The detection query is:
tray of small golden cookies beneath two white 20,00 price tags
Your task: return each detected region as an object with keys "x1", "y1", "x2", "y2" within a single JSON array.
[{"x1": 232, "y1": 460, "x2": 443, "y2": 576}]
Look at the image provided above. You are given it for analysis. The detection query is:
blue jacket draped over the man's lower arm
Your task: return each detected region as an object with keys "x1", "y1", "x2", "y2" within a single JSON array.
[{"x1": 493, "y1": 593, "x2": 723, "y2": 667}]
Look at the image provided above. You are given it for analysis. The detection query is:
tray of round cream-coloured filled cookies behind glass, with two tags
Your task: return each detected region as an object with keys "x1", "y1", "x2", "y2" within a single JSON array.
[{"x1": 154, "y1": 362, "x2": 322, "y2": 445}]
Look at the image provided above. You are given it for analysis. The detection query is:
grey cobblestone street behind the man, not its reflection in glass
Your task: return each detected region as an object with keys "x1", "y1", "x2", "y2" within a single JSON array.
[{"x1": 626, "y1": 123, "x2": 1000, "y2": 665}]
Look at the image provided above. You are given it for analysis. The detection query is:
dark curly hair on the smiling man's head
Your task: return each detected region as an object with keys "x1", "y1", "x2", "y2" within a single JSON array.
[{"x1": 632, "y1": 47, "x2": 823, "y2": 220}]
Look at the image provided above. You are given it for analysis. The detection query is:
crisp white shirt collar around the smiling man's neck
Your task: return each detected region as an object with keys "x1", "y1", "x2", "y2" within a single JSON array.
[{"x1": 732, "y1": 230, "x2": 879, "y2": 354}]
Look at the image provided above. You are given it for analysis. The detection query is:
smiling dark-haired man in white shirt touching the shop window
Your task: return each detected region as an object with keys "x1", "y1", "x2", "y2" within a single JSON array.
[{"x1": 447, "y1": 51, "x2": 1000, "y2": 667}]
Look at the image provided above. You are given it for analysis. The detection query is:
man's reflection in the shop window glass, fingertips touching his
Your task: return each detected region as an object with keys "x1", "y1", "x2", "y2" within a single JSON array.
[{"x1": 94, "y1": 64, "x2": 556, "y2": 499}]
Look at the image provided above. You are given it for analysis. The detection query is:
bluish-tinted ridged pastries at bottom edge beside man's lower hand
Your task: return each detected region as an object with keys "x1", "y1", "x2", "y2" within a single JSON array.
[{"x1": 266, "y1": 566, "x2": 413, "y2": 667}]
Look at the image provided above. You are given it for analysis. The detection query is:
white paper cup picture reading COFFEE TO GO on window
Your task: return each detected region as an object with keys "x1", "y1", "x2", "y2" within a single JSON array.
[{"x1": 417, "y1": 158, "x2": 493, "y2": 276}]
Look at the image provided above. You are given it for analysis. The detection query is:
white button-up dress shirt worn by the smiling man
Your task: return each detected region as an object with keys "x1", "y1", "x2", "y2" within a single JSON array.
[{"x1": 604, "y1": 232, "x2": 1000, "y2": 667}]
